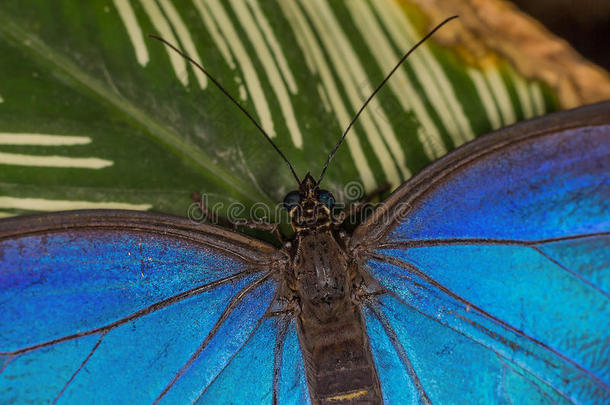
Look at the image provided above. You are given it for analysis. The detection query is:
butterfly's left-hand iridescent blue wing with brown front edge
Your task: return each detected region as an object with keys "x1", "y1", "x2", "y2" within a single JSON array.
[{"x1": 0, "y1": 211, "x2": 304, "y2": 403}]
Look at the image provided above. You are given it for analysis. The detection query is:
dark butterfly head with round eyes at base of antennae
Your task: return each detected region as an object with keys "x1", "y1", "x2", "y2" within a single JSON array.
[{"x1": 284, "y1": 173, "x2": 335, "y2": 232}]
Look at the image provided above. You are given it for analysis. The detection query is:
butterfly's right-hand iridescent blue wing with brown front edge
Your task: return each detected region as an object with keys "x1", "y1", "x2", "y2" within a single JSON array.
[{"x1": 352, "y1": 103, "x2": 610, "y2": 403}]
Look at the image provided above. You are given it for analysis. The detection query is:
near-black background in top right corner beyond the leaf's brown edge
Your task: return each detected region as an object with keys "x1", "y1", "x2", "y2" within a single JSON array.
[{"x1": 513, "y1": 0, "x2": 610, "y2": 70}]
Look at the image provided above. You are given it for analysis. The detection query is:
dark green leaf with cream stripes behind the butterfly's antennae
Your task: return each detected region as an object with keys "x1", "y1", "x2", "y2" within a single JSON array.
[{"x1": 0, "y1": 0, "x2": 558, "y2": 224}]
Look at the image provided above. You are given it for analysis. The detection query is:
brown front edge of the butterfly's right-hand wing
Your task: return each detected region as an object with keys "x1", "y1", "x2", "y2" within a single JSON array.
[{"x1": 350, "y1": 101, "x2": 610, "y2": 250}]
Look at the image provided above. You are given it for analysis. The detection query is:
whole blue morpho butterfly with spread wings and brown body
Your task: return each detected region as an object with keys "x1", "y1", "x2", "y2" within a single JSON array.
[{"x1": 0, "y1": 15, "x2": 610, "y2": 404}]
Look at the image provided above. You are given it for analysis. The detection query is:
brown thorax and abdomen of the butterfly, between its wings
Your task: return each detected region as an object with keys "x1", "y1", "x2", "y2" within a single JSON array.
[{"x1": 294, "y1": 233, "x2": 381, "y2": 404}]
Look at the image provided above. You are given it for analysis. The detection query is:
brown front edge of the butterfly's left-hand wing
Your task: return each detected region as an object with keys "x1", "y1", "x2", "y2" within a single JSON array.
[{"x1": 0, "y1": 209, "x2": 282, "y2": 267}]
